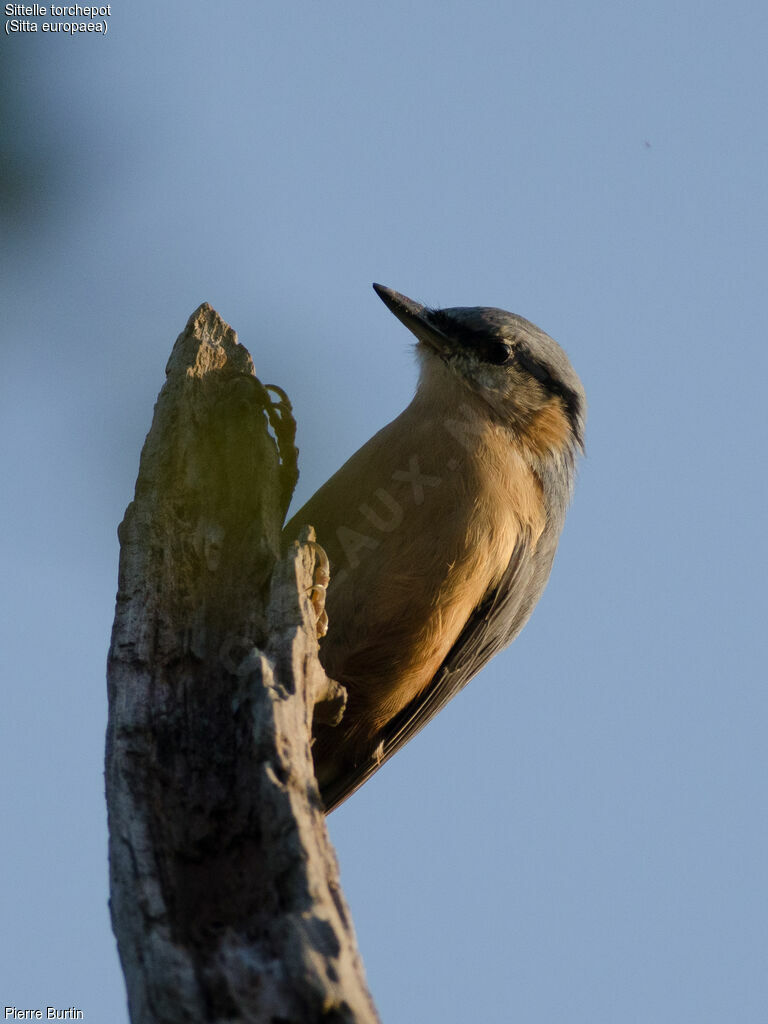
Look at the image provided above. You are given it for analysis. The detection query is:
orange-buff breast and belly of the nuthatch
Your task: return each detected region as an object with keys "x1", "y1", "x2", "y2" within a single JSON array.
[{"x1": 316, "y1": 411, "x2": 545, "y2": 745}]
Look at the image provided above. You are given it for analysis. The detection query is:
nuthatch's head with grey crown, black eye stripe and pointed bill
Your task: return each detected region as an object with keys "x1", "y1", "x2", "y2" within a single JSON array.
[{"x1": 374, "y1": 285, "x2": 587, "y2": 455}]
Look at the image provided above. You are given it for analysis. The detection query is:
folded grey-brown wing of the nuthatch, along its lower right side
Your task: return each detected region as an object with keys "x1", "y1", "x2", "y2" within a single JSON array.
[{"x1": 322, "y1": 535, "x2": 540, "y2": 811}]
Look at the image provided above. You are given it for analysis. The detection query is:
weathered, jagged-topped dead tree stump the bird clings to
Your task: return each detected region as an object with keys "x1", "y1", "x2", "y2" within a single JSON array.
[{"x1": 106, "y1": 304, "x2": 378, "y2": 1024}]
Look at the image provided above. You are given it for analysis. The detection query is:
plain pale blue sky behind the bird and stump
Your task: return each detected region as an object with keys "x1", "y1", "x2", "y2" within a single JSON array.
[{"x1": 0, "y1": 0, "x2": 768, "y2": 1024}]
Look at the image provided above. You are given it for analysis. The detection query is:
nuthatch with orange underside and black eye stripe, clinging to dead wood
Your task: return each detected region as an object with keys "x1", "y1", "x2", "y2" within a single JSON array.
[{"x1": 284, "y1": 284, "x2": 587, "y2": 813}]
